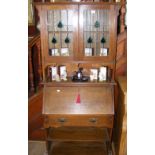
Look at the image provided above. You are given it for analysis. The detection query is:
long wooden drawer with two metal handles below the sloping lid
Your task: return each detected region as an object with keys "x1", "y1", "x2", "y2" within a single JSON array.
[{"x1": 44, "y1": 115, "x2": 114, "y2": 128}]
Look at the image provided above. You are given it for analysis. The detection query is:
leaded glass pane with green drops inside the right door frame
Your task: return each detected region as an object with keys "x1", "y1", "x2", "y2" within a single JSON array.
[{"x1": 83, "y1": 10, "x2": 109, "y2": 56}]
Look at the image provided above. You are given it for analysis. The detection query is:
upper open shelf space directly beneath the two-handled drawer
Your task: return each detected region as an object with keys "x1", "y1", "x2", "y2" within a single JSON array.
[{"x1": 47, "y1": 127, "x2": 109, "y2": 142}]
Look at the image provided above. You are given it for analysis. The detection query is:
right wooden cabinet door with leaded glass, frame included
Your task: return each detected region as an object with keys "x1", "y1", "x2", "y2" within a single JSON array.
[{"x1": 79, "y1": 4, "x2": 117, "y2": 62}]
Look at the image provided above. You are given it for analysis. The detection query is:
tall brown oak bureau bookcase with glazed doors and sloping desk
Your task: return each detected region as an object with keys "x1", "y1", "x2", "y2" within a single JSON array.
[{"x1": 35, "y1": 2, "x2": 119, "y2": 154}]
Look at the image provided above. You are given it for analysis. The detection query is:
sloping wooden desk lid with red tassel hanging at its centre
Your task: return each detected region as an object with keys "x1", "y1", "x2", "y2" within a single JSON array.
[{"x1": 43, "y1": 86, "x2": 114, "y2": 115}]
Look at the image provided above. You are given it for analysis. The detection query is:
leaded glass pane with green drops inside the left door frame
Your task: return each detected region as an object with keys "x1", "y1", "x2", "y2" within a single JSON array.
[{"x1": 46, "y1": 10, "x2": 74, "y2": 56}]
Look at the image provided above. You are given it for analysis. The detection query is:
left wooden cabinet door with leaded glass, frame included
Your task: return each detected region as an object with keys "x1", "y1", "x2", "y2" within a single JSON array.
[{"x1": 40, "y1": 4, "x2": 78, "y2": 64}]
